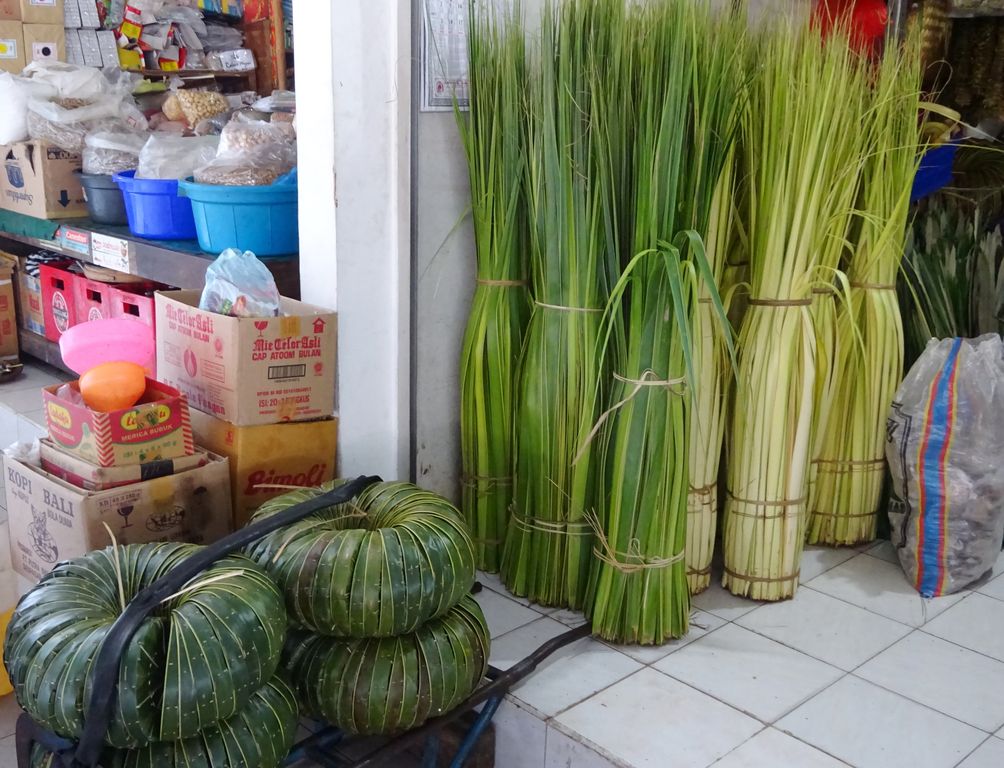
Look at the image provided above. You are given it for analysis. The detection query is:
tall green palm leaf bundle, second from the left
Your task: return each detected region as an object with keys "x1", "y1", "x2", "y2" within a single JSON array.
[{"x1": 501, "y1": 0, "x2": 626, "y2": 608}]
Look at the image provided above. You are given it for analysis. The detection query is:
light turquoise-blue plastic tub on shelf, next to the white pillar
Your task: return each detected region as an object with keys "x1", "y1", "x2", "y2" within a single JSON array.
[{"x1": 178, "y1": 181, "x2": 300, "y2": 256}]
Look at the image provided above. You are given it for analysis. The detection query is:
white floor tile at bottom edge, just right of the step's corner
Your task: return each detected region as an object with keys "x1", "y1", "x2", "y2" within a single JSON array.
[{"x1": 554, "y1": 668, "x2": 761, "y2": 768}]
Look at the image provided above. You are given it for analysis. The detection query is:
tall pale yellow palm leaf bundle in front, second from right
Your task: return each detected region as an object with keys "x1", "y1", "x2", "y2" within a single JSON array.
[{"x1": 723, "y1": 20, "x2": 860, "y2": 600}]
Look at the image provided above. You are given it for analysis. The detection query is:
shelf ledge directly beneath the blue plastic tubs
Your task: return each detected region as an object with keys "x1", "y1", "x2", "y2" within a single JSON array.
[{"x1": 0, "y1": 219, "x2": 300, "y2": 298}]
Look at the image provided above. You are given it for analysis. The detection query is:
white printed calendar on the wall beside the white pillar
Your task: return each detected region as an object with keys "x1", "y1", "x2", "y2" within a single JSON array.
[{"x1": 421, "y1": 0, "x2": 469, "y2": 112}]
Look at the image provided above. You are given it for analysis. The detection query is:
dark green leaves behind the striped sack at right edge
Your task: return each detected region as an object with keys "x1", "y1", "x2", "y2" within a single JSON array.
[{"x1": 900, "y1": 195, "x2": 1004, "y2": 364}]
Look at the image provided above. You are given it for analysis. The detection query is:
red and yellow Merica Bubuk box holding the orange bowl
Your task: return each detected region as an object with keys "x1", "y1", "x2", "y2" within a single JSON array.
[{"x1": 42, "y1": 378, "x2": 195, "y2": 467}]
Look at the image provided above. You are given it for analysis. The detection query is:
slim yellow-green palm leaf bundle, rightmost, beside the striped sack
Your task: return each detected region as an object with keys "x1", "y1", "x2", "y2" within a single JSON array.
[{"x1": 808, "y1": 37, "x2": 922, "y2": 545}]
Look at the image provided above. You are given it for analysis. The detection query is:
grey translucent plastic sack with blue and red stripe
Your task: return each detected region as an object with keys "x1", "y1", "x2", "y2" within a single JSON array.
[{"x1": 886, "y1": 334, "x2": 1004, "y2": 597}]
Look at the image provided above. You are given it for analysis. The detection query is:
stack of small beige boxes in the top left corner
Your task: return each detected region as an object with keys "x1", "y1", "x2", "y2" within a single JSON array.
[{"x1": 0, "y1": 0, "x2": 65, "y2": 74}]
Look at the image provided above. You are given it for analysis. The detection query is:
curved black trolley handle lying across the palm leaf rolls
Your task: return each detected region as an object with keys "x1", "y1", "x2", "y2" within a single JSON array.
[{"x1": 17, "y1": 476, "x2": 381, "y2": 768}]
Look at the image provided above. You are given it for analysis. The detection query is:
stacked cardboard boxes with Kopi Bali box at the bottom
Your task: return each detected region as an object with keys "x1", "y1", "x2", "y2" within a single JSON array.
[{"x1": 4, "y1": 357, "x2": 232, "y2": 580}]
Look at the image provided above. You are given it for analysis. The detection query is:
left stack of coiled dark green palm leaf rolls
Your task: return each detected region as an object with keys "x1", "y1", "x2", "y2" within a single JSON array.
[{"x1": 4, "y1": 544, "x2": 298, "y2": 768}]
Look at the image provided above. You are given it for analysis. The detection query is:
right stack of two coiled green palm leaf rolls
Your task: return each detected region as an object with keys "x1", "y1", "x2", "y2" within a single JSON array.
[{"x1": 248, "y1": 475, "x2": 490, "y2": 734}]
